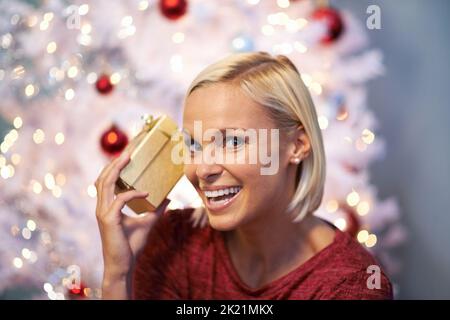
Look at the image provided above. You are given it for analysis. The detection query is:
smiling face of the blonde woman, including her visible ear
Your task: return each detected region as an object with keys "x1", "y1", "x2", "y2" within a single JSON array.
[{"x1": 183, "y1": 84, "x2": 296, "y2": 231}]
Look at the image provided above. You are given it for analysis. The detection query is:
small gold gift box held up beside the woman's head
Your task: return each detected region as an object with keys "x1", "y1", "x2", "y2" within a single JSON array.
[{"x1": 115, "y1": 115, "x2": 183, "y2": 213}]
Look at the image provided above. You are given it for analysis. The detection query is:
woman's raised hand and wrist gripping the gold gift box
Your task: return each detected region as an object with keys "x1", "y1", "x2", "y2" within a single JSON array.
[{"x1": 95, "y1": 152, "x2": 169, "y2": 299}]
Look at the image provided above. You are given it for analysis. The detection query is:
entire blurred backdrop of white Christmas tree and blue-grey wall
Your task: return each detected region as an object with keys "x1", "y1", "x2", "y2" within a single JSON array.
[{"x1": 0, "y1": 0, "x2": 450, "y2": 299}]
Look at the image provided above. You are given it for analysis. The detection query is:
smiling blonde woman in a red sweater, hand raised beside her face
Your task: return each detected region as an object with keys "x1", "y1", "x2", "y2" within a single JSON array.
[{"x1": 96, "y1": 52, "x2": 392, "y2": 299}]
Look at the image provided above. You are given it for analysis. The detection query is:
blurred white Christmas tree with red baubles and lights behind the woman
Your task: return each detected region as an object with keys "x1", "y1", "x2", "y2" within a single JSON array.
[{"x1": 0, "y1": 0, "x2": 405, "y2": 299}]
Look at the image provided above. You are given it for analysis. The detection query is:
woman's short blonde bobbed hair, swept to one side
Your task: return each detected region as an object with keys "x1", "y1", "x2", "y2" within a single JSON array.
[{"x1": 185, "y1": 52, "x2": 325, "y2": 222}]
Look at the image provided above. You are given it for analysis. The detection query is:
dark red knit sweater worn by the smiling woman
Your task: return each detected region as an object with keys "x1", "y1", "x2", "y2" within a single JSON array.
[{"x1": 132, "y1": 209, "x2": 392, "y2": 299}]
